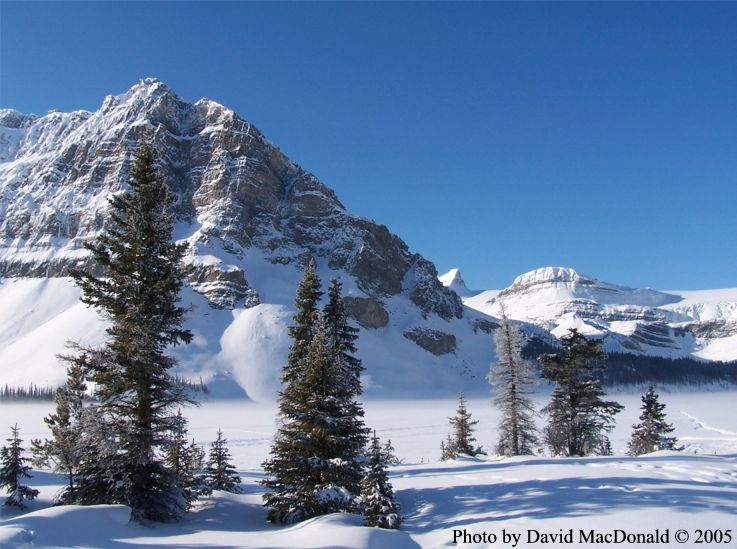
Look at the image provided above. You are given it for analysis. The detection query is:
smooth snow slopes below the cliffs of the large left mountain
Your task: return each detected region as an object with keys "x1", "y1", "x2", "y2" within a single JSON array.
[{"x1": 0, "y1": 270, "x2": 494, "y2": 402}]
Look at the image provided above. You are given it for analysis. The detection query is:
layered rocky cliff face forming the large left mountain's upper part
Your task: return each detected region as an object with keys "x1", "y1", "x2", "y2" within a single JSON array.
[{"x1": 0, "y1": 79, "x2": 462, "y2": 319}]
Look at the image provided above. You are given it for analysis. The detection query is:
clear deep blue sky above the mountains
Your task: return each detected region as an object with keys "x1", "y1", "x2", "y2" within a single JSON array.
[{"x1": 0, "y1": 0, "x2": 737, "y2": 289}]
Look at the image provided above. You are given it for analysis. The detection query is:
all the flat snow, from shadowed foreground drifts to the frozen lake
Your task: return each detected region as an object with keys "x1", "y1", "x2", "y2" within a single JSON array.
[{"x1": 0, "y1": 392, "x2": 737, "y2": 549}]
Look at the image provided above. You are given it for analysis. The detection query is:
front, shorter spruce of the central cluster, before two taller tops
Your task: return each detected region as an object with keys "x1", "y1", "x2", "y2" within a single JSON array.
[{"x1": 263, "y1": 313, "x2": 363, "y2": 523}]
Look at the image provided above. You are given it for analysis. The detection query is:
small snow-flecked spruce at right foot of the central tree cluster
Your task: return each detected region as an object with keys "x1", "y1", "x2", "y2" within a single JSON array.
[{"x1": 361, "y1": 432, "x2": 402, "y2": 529}]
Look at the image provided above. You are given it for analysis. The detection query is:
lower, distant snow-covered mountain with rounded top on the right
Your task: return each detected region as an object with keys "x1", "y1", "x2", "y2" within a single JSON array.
[{"x1": 448, "y1": 267, "x2": 737, "y2": 361}]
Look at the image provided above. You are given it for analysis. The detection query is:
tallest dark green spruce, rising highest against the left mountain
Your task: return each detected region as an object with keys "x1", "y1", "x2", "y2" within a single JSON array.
[{"x1": 73, "y1": 143, "x2": 192, "y2": 521}]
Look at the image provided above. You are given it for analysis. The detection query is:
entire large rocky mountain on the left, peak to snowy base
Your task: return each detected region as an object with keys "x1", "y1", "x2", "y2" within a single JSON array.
[{"x1": 0, "y1": 79, "x2": 493, "y2": 400}]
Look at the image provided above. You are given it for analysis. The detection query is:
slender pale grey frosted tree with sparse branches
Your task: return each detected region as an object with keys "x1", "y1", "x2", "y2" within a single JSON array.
[{"x1": 489, "y1": 307, "x2": 537, "y2": 456}]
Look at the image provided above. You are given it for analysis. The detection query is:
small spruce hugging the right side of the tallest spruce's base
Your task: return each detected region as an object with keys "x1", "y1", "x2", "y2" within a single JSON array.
[{"x1": 164, "y1": 411, "x2": 208, "y2": 507}]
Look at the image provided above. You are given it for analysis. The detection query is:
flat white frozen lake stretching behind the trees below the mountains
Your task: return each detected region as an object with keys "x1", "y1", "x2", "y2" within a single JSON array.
[{"x1": 0, "y1": 391, "x2": 737, "y2": 470}]
